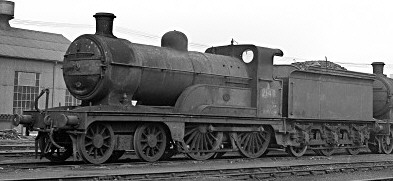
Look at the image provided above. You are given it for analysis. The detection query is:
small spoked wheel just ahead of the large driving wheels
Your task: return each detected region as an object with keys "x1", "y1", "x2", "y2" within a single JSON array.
[{"x1": 134, "y1": 123, "x2": 168, "y2": 162}]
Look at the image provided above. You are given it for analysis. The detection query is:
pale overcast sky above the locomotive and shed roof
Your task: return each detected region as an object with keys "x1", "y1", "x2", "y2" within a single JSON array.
[{"x1": 10, "y1": 0, "x2": 393, "y2": 75}]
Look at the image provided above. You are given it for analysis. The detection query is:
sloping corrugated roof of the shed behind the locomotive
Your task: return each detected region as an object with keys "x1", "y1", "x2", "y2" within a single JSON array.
[{"x1": 0, "y1": 25, "x2": 71, "y2": 61}]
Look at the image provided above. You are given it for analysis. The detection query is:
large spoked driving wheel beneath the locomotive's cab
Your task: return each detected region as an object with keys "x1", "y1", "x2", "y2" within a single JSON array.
[{"x1": 233, "y1": 126, "x2": 271, "y2": 158}]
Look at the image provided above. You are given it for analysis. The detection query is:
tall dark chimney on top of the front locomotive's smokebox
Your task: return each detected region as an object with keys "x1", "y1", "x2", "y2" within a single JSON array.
[{"x1": 93, "y1": 13, "x2": 116, "y2": 38}]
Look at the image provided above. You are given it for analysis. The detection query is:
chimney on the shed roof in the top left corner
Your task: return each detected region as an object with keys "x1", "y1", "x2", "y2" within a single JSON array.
[{"x1": 0, "y1": 0, "x2": 15, "y2": 30}]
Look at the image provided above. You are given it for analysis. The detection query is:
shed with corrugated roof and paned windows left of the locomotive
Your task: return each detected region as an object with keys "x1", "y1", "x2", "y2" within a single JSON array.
[{"x1": 0, "y1": 0, "x2": 76, "y2": 130}]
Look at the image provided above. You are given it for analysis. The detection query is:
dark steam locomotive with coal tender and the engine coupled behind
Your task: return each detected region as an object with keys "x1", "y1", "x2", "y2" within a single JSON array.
[{"x1": 14, "y1": 13, "x2": 393, "y2": 164}]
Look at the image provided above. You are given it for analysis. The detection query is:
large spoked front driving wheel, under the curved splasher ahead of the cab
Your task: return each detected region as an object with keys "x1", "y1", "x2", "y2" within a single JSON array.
[{"x1": 184, "y1": 124, "x2": 224, "y2": 160}]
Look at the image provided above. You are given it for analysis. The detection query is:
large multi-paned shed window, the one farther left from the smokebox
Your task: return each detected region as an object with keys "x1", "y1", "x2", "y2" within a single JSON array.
[{"x1": 13, "y1": 71, "x2": 40, "y2": 114}]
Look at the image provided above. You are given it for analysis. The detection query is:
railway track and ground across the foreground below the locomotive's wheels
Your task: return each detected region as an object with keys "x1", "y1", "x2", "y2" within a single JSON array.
[{"x1": 0, "y1": 155, "x2": 393, "y2": 180}]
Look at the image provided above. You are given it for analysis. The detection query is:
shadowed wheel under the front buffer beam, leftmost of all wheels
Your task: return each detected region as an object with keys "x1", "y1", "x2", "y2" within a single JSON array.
[{"x1": 38, "y1": 132, "x2": 72, "y2": 162}]
